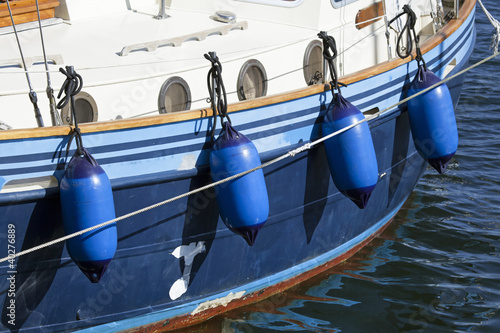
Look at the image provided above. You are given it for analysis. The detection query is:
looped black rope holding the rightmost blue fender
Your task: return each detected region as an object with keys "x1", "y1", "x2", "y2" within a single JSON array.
[{"x1": 388, "y1": 5, "x2": 427, "y2": 69}]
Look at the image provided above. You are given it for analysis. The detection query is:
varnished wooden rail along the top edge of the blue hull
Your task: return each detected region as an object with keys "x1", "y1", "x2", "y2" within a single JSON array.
[{"x1": 0, "y1": 0, "x2": 476, "y2": 140}]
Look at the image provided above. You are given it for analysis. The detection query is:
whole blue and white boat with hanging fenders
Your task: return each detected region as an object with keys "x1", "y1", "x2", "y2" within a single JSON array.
[{"x1": 0, "y1": 0, "x2": 476, "y2": 332}]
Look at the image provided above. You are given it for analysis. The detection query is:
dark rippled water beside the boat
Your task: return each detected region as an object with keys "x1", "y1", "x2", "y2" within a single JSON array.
[{"x1": 176, "y1": 0, "x2": 500, "y2": 332}]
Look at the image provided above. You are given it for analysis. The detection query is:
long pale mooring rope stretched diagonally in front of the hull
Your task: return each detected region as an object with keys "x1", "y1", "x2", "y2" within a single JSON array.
[{"x1": 0, "y1": 5, "x2": 500, "y2": 262}]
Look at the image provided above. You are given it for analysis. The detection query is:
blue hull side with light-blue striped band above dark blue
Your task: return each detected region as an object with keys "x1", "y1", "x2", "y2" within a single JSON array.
[{"x1": 0, "y1": 4, "x2": 475, "y2": 332}]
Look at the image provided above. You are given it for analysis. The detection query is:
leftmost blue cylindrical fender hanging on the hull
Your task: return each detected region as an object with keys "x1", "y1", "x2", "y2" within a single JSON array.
[{"x1": 60, "y1": 149, "x2": 117, "y2": 283}]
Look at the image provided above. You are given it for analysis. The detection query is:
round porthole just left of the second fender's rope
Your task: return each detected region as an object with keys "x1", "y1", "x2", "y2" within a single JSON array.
[{"x1": 158, "y1": 76, "x2": 191, "y2": 113}]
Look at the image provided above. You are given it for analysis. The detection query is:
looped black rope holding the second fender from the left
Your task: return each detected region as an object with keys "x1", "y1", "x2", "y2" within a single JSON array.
[{"x1": 205, "y1": 52, "x2": 231, "y2": 140}]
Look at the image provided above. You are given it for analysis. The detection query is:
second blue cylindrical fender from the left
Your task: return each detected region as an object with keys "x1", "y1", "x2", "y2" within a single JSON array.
[{"x1": 210, "y1": 122, "x2": 269, "y2": 246}]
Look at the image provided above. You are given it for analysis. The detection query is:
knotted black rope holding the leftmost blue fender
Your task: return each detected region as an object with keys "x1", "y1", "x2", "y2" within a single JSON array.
[{"x1": 57, "y1": 66, "x2": 84, "y2": 155}]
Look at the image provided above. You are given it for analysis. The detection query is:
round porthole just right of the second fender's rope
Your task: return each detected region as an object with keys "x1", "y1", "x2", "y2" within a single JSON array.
[{"x1": 236, "y1": 59, "x2": 267, "y2": 101}]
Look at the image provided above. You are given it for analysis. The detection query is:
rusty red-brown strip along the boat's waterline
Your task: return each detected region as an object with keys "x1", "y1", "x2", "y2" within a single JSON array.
[{"x1": 121, "y1": 212, "x2": 397, "y2": 333}]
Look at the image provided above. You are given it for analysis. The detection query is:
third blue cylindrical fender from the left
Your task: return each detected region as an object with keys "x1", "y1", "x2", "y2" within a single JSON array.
[{"x1": 322, "y1": 93, "x2": 378, "y2": 209}]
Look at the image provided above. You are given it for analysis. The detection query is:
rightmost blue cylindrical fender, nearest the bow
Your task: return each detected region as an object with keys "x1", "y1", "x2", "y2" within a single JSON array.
[{"x1": 408, "y1": 65, "x2": 458, "y2": 173}]
